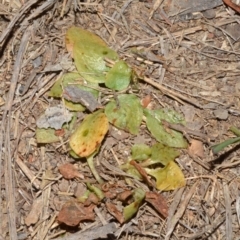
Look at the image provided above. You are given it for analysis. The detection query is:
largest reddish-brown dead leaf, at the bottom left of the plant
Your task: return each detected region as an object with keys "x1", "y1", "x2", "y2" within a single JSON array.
[{"x1": 57, "y1": 201, "x2": 95, "y2": 227}]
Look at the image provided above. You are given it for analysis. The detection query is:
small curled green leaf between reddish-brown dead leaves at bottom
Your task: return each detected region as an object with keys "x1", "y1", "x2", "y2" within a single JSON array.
[{"x1": 123, "y1": 188, "x2": 145, "y2": 222}]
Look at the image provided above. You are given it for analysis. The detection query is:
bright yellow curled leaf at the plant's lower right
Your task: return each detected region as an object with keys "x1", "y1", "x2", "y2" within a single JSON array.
[{"x1": 145, "y1": 161, "x2": 186, "y2": 191}]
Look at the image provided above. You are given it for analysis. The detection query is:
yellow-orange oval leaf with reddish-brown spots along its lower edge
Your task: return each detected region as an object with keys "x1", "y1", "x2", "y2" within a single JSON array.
[{"x1": 69, "y1": 110, "x2": 108, "y2": 157}]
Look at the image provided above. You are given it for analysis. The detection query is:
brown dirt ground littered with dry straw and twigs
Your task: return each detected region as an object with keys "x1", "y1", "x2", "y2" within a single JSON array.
[{"x1": 0, "y1": 0, "x2": 240, "y2": 240}]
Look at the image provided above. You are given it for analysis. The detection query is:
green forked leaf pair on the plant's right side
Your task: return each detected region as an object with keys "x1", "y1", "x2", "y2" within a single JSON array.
[{"x1": 144, "y1": 109, "x2": 188, "y2": 148}]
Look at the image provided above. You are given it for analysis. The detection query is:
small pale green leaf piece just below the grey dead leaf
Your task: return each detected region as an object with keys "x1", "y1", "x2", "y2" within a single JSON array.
[{"x1": 36, "y1": 128, "x2": 60, "y2": 143}]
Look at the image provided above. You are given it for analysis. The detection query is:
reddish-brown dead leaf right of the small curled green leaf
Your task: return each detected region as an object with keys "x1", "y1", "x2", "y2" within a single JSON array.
[{"x1": 145, "y1": 192, "x2": 168, "y2": 218}]
